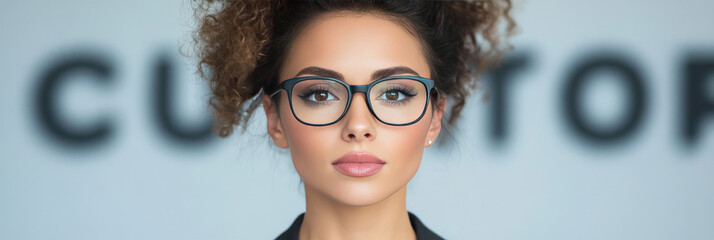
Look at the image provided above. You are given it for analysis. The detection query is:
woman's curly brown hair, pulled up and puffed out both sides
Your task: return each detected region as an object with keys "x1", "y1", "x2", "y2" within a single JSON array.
[{"x1": 193, "y1": 0, "x2": 516, "y2": 137}]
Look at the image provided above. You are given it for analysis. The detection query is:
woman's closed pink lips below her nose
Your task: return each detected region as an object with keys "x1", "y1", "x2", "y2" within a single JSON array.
[{"x1": 332, "y1": 152, "x2": 386, "y2": 177}]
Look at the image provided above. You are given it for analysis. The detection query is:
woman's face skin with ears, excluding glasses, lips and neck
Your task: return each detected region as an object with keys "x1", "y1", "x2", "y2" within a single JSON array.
[{"x1": 263, "y1": 13, "x2": 443, "y2": 206}]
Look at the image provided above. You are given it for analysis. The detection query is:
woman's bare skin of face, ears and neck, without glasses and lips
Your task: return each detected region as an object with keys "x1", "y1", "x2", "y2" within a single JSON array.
[{"x1": 262, "y1": 12, "x2": 445, "y2": 239}]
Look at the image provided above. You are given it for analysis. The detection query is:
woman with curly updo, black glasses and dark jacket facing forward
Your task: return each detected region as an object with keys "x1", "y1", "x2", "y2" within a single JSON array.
[{"x1": 186, "y1": 0, "x2": 515, "y2": 239}]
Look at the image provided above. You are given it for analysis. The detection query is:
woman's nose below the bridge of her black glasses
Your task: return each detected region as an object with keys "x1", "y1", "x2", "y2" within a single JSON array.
[{"x1": 342, "y1": 93, "x2": 377, "y2": 142}]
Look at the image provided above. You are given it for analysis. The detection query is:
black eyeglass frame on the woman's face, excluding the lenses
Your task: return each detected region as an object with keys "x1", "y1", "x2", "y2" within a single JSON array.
[{"x1": 269, "y1": 76, "x2": 439, "y2": 127}]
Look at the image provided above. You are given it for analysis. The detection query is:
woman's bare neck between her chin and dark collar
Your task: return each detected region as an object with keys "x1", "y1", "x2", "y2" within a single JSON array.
[{"x1": 299, "y1": 185, "x2": 416, "y2": 240}]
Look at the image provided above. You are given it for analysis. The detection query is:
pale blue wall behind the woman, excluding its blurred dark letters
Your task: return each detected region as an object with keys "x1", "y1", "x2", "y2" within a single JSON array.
[{"x1": 0, "y1": 0, "x2": 714, "y2": 239}]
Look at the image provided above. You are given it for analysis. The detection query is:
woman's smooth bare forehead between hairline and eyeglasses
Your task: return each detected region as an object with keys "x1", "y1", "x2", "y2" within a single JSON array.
[{"x1": 280, "y1": 12, "x2": 430, "y2": 84}]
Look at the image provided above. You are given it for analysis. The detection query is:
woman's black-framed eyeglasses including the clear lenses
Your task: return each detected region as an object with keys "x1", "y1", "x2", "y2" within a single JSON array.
[{"x1": 270, "y1": 76, "x2": 436, "y2": 126}]
